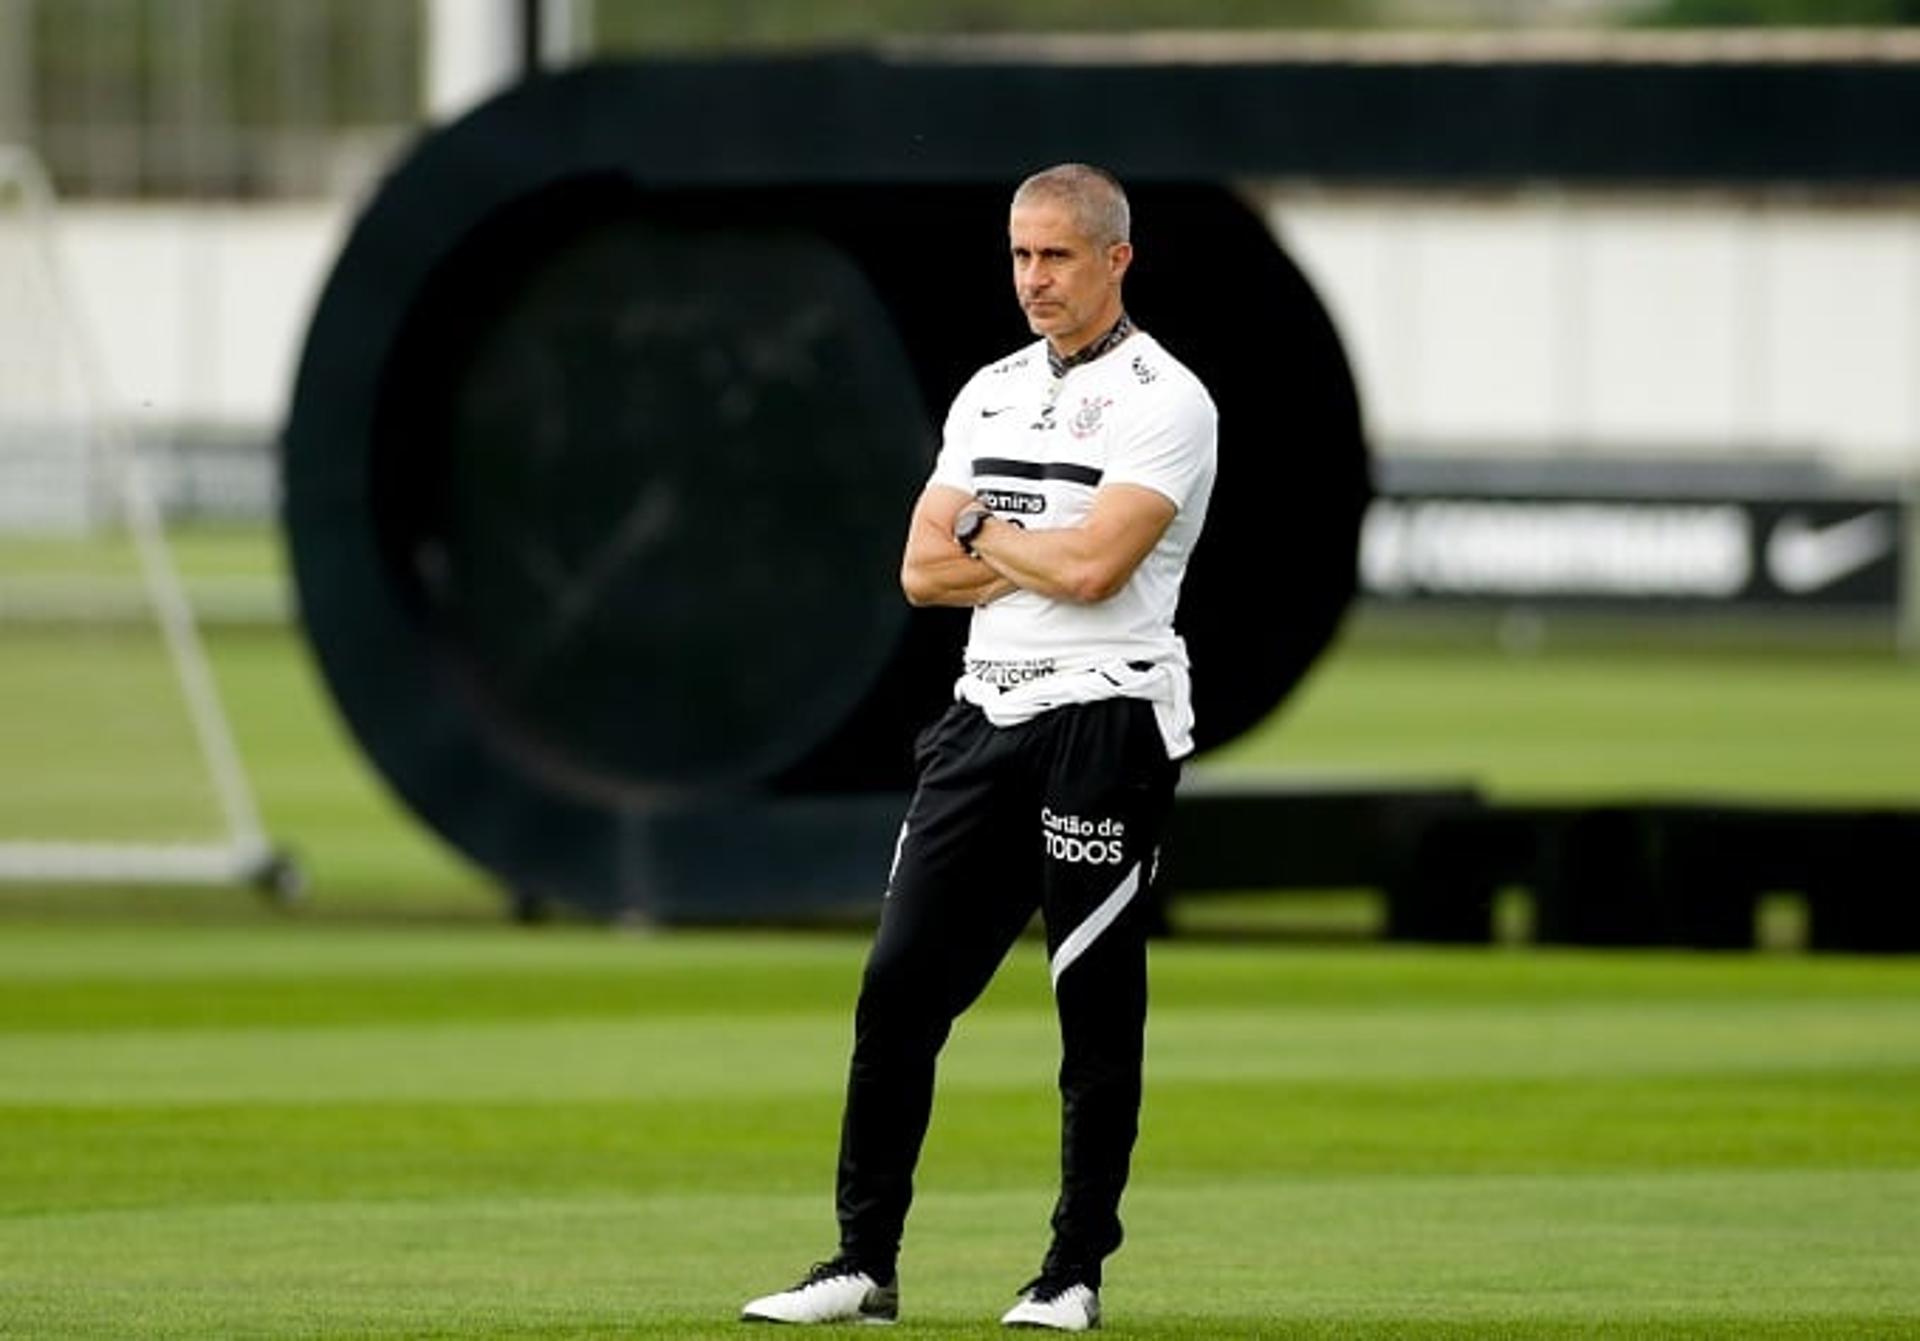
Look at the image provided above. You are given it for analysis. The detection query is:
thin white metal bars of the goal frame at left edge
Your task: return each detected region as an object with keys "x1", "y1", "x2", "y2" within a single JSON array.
[{"x1": 0, "y1": 144, "x2": 300, "y2": 899}]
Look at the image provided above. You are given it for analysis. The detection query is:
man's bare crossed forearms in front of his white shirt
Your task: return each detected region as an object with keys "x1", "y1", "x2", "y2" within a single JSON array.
[{"x1": 900, "y1": 484, "x2": 1175, "y2": 605}]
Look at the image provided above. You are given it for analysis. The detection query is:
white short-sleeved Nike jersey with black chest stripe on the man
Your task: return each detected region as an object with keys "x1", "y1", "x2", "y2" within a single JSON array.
[{"x1": 933, "y1": 330, "x2": 1217, "y2": 753}]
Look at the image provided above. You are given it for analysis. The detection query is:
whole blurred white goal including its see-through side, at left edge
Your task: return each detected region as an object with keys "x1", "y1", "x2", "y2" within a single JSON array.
[{"x1": 0, "y1": 144, "x2": 298, "y2": 897}]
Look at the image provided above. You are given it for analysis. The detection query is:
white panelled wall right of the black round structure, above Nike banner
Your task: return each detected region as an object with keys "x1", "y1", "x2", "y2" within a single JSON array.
[{"x1": 1263, "y1": 190, "x2": 1920, "y2": 476}]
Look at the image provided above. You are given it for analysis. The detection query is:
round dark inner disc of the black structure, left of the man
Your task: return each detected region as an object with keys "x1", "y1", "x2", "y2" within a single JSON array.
[{"x1": 371, "y1": 179, "x2": 925, "y2": 799}]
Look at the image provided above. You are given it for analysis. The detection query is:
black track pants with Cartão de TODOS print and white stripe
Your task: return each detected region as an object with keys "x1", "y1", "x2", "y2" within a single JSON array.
[{"x1": 837, "y1": 699, "x2": 1179, "y2": 1283}]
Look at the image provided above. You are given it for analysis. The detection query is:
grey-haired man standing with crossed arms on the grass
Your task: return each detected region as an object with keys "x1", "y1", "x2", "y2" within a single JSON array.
[{"x1": 741, "y1": 163, "x2": 1215, "y2": 1331}]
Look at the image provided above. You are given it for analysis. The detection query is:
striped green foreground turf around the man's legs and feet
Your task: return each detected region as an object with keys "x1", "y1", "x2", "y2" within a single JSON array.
[{"x1": 0, "y1": 920, "x2": 1920, "y2": 1337}]
